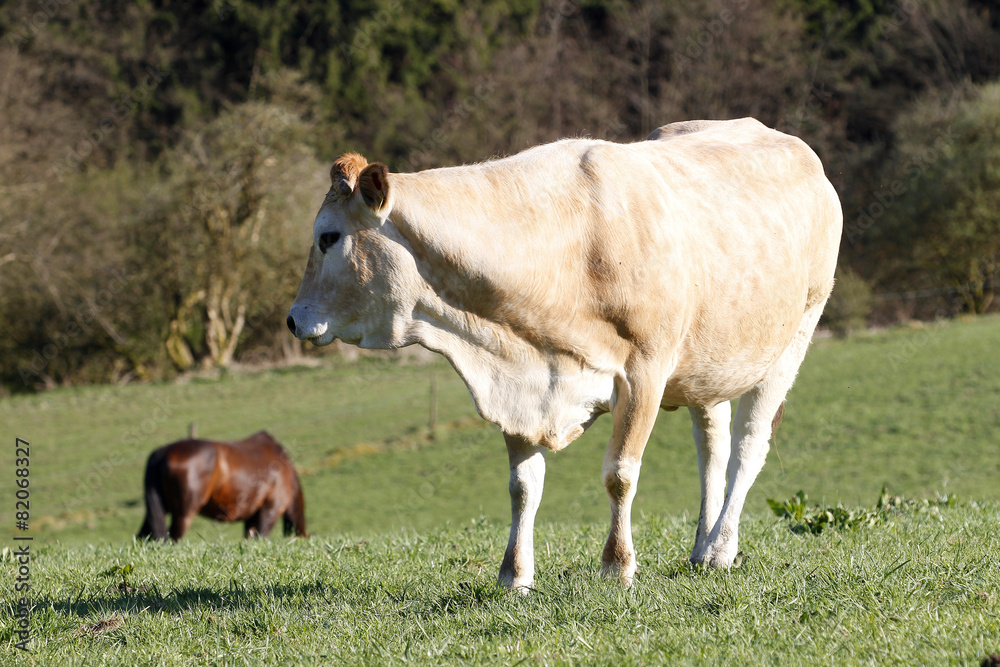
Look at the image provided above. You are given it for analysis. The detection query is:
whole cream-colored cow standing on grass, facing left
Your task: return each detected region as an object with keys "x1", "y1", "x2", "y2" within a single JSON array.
[{"x1": 288, "y1": 119, "x2": 842, "y2": 588}]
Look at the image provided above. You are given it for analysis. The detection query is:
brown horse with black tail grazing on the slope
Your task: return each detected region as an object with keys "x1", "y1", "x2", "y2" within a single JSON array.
[{"x1": 138, "y1": 431, "x2": 306, "y2": 541}]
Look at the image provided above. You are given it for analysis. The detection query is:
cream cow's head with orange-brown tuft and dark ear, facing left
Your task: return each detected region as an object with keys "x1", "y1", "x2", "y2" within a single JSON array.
[{"x1": 288, "y1": 153, "x2": 407, "y2": 347}]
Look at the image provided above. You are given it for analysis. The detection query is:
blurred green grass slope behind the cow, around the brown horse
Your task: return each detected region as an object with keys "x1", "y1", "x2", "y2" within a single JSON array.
[{"x1": 0, "y1": 317, "x2": 1000, "y2": 544}]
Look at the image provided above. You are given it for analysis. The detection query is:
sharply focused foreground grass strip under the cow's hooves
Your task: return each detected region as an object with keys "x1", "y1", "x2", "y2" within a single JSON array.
[{"x1": 0, "y1": 503, "x2": 1000, "y2": 665}]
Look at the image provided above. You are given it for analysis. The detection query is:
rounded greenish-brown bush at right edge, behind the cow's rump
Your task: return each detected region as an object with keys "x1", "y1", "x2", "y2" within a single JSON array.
[{"x1": 872, "y1": 82, "x2": 1000, "y2": 314}]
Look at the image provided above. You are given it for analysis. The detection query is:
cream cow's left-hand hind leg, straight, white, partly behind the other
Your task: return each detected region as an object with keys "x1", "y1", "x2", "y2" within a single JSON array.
[{"x1": 689, "y1": 401, "x2": 732, "y2": 553}]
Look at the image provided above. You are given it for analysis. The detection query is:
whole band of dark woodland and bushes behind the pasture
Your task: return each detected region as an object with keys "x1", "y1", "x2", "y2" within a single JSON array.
[{"x1": 0, "y1": 0, "x2": 1000, "y2": 394}]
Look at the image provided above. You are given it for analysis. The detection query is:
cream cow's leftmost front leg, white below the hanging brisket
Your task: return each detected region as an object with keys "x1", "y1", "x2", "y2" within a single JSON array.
[{"x1": 499, "y1": 434, "x2": 548, "y2": 592}]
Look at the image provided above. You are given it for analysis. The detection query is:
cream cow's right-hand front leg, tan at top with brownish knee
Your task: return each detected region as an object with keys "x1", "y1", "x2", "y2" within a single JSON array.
[{"x1": 601, "y1": 380, "x2": 663, "y2": 586}]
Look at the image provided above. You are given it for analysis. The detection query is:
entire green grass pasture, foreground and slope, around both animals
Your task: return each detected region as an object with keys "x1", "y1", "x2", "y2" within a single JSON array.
[{"x1": 0, "y1": 317, "x2": 1000, "y2": 664}]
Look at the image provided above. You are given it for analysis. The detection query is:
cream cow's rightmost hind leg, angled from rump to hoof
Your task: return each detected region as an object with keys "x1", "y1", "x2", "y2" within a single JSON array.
[{"x1": 691, "y1": 303, "x2": 823, "y2": 567}]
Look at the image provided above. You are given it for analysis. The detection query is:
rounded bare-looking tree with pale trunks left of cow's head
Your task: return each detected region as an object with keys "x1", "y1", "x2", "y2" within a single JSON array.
[{"x1": 132, "y1": 102, "x2": 327, "y2": 370}]
